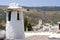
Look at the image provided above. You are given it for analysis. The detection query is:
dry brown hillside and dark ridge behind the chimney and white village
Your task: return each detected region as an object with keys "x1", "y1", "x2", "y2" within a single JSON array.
[{"x1": 0, "y1": 6, "x2": 60, "y2": 25}]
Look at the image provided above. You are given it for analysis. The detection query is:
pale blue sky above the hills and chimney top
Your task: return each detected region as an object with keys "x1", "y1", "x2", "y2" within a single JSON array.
[{"x1": 0, "y1": 0, "x2": 60, "y2": 6}]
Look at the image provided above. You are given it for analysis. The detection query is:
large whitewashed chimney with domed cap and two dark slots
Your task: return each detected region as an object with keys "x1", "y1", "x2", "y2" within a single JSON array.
[{"x1": 6, "y1": 3, "x2": 25, "y2": 40}]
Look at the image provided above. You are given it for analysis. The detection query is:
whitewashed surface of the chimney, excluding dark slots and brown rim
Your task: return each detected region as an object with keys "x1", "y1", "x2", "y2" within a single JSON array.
[{"x1": 6, "y1": 4, "x2": 24, "y2": 40}]
